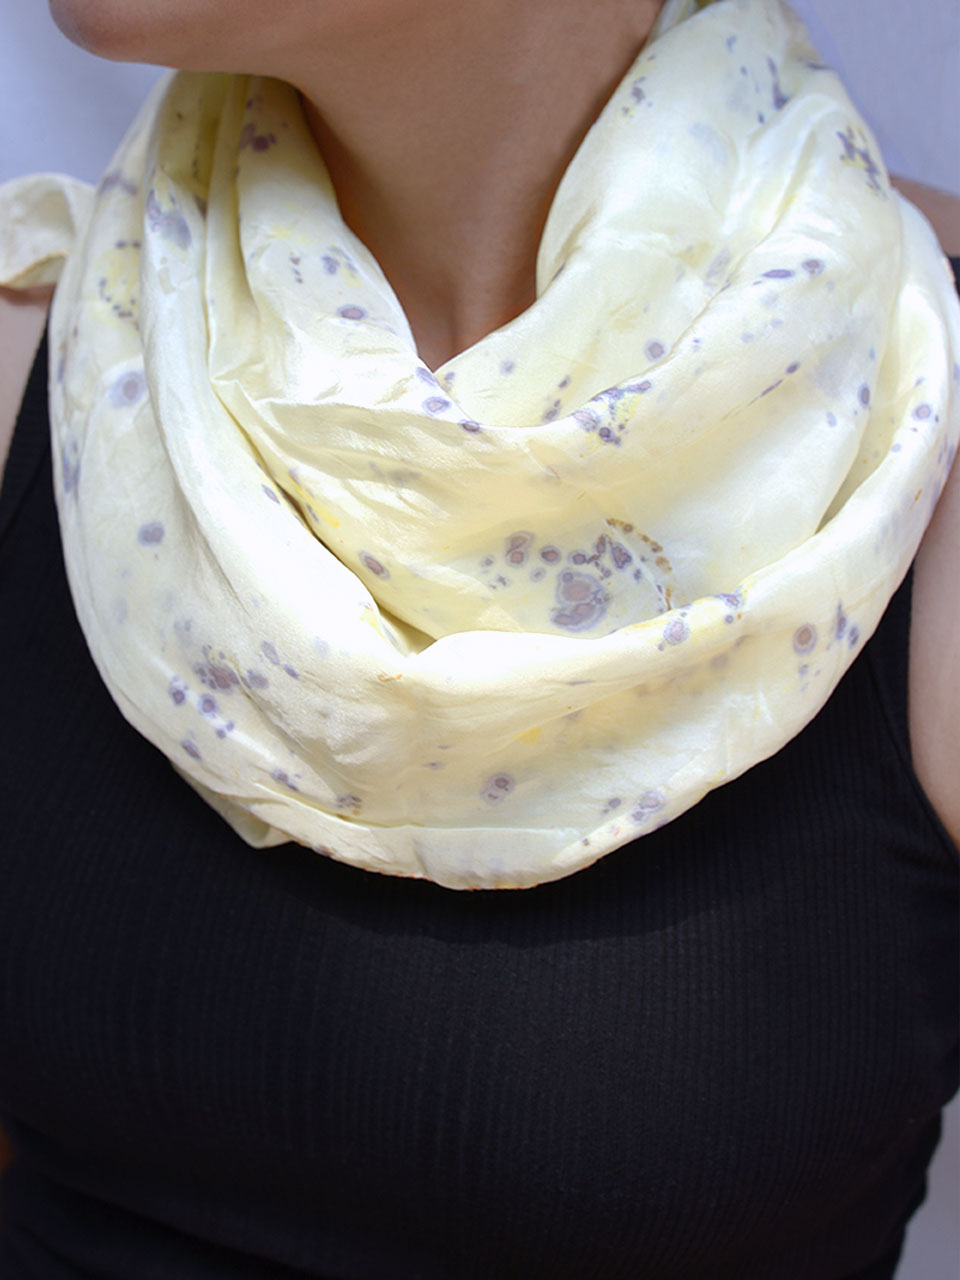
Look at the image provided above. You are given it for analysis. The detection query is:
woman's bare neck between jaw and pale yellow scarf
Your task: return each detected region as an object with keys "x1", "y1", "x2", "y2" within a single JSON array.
[{"x1": 296, "y1": 0, "x2": 662, "y2": 369}]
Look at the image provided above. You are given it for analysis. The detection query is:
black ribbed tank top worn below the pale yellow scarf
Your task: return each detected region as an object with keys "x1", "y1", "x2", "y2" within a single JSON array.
[{"x1": 0, "y1": 304, "x2": 959, "y2": 1280}]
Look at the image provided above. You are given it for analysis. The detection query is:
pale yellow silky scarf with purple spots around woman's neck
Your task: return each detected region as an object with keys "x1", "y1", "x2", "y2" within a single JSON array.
[{"x1": 0, "y1": 0, "x2": 960, "y2": 888}]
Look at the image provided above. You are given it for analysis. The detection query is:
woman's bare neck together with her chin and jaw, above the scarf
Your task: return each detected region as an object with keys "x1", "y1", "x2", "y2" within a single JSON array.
[{"x1": 52, "y1": 0, "x2": 663, "y2": 367}]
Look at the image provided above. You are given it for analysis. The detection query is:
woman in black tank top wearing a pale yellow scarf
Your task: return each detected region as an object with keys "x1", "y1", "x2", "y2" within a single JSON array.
[{"x1": 0, "y1": 0, "x2": 960, "y2": 1277}]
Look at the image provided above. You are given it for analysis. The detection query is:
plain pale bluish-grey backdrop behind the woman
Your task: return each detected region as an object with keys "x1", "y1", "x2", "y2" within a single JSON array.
[{"x1": 0, "y1": 0, "x2": 960, "y2": 1280}]
